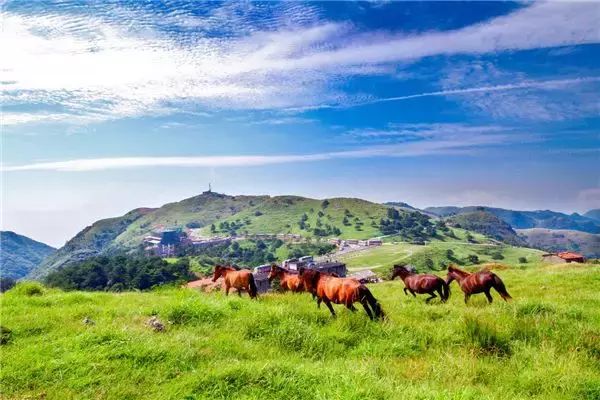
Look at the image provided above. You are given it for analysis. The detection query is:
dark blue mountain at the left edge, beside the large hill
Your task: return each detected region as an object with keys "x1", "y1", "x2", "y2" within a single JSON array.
[{"x1": 0, "y1": 231, "x2": 55, "y2": 279}]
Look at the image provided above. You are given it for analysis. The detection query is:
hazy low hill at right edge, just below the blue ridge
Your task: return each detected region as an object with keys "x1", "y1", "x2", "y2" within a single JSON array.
[{"x1": 517, "y1": 228, "x2": 600, "y2": 258}]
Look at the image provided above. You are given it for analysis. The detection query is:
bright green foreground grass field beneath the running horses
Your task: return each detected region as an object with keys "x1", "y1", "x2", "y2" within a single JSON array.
[{"x1": 0, "y1": 265, "x2": 600, "y2": 400}]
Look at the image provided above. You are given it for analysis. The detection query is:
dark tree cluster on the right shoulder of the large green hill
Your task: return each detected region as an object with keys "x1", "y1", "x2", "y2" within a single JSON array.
[{"x1": 379, "y1": 208, "x2": 437, "y2": 241}]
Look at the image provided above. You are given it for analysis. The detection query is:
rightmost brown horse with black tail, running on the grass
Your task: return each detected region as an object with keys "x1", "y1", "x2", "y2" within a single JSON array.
[{"x1": 446, "y1": 265, "x2": 512, "y2": 304}]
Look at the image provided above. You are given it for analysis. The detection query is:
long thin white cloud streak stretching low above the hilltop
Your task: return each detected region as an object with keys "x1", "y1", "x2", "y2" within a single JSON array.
[{"x1": 2, "y1": 124, "x2": 524, "y2": 172}]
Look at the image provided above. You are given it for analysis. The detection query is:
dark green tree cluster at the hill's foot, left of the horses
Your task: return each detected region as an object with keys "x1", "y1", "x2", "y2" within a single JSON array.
[{"x1": 45, "y1": 255, "x2": 192, "y2": 291}]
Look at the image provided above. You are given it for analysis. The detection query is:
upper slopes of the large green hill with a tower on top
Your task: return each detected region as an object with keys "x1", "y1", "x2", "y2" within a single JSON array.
[{"x1": 29, "y1": 192, "x2": 440, "y2": 279}]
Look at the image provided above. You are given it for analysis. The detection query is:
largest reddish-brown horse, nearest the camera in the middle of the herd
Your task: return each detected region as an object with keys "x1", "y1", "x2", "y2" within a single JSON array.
[{"x1": 300, "y1": 269, "x2": 385, "y2": 320}]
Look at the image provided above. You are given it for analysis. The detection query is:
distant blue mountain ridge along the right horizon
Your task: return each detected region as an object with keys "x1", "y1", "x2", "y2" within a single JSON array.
[{"x1": 424, "y1": 206, "x2": 600, "y2": 233}]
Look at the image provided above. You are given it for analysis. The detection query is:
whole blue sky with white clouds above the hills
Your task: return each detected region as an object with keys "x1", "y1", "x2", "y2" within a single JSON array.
[{"x1": 0, "y1": 0, "x2": 600, "y2": 246}]
